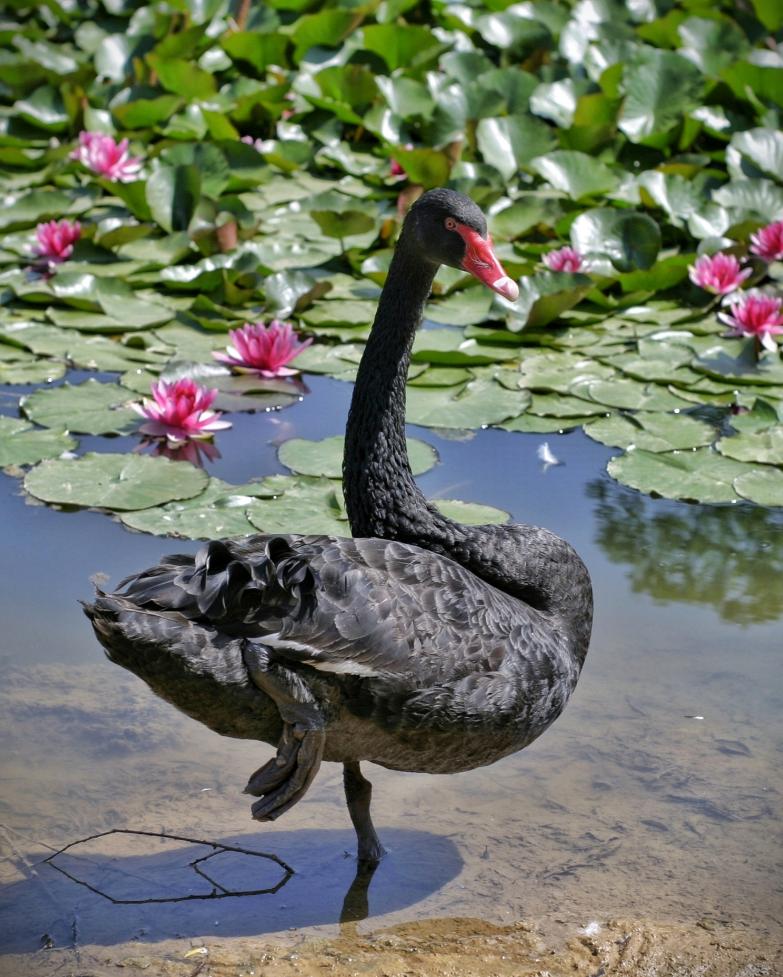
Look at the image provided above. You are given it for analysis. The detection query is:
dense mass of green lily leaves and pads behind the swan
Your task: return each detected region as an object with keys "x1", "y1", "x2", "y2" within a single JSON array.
[{"x1": 0, "y1": 0, "x2": 783, "y2": 535}]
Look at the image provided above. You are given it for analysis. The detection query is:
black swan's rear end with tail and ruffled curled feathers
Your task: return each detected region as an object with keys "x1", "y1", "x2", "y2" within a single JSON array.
[{"x1": 79, "y1": 537, "x2": 316, "y2": 742}]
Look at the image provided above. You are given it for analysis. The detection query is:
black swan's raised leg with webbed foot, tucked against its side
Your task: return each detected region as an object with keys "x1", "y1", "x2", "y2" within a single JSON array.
[{"x1": 243, "y1": 643, "x2": 326, "y2": 821}]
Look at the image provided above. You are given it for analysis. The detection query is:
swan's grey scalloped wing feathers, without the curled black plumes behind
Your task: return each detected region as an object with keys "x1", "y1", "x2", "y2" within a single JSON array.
[{"x1": 263, "y1": 539, "x2": 511, "y2": 682}]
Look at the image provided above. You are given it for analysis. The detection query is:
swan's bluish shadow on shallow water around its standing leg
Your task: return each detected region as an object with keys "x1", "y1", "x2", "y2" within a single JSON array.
[{"x1": 0, "y1": 829, "x2": 463, "y2": 953}]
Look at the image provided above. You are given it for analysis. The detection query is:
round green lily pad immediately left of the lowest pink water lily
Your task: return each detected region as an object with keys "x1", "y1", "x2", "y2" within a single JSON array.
[{"x1": 20, "y1": 380, "x2": 139, "y2": 434}]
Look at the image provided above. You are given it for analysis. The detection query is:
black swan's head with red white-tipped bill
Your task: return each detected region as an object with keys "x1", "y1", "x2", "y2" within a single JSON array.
[{"x1": 405, "y1": 189, "x2": 519, "y2": 302}]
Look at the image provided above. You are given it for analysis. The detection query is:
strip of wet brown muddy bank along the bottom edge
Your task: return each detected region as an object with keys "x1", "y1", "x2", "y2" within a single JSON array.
[{"x1": 0, "y1": 919, "x2": 783, "y2": 977}]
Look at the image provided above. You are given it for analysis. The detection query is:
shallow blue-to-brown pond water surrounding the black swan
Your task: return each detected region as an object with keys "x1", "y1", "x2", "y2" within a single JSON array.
[{"x1": 0, "y1": 370, "x2": 783, "y2": 974}]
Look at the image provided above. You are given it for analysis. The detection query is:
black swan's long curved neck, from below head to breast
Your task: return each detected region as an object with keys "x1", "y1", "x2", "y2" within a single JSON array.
[{"x1": 343, "y1": 231, "x2": 592, "y2": 664}]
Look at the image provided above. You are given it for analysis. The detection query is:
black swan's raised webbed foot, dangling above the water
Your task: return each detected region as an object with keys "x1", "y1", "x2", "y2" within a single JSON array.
[{"x1": 245, "y1": 723, "x2": 326, "y2": 821}]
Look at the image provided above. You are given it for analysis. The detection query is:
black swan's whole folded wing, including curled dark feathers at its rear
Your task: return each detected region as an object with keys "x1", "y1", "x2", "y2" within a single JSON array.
[{"x1": 115, "y1": 536, "x2": 524, "y2": 682}]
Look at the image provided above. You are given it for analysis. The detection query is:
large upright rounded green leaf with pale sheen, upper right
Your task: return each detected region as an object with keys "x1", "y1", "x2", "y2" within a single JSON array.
[{"x1": 617, "y1": 48, "x2": 704, "y2": 146}]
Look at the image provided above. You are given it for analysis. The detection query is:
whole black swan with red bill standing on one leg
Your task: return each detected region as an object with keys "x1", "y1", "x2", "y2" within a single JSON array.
[{"x1": 85, "y1": 189, "x2": 593, "y2": 864}]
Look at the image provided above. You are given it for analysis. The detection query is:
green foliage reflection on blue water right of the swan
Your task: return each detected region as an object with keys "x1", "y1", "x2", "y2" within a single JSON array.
[{"x1": 587, "y1": 479, "x2": 783, "y2": 625}]
